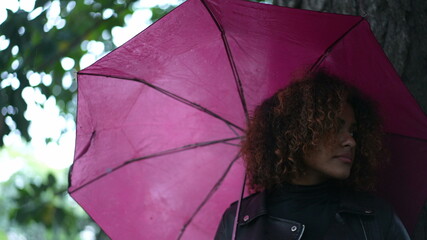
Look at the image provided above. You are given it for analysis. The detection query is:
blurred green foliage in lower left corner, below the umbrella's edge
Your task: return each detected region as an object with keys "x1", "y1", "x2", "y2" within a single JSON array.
[{"x1": 0, "y1": 173, "x2": 108, "y2": 240}]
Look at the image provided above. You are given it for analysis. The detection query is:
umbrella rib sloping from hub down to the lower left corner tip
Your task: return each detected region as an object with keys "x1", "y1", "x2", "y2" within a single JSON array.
[{"x1": 70, "y1": 137, "x2": 242, "y2": 194}]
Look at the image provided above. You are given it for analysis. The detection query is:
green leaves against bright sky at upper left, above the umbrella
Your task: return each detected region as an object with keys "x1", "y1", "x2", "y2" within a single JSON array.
[{"x1": 0, "y1": 0, "x2": 176, "y2": 146}]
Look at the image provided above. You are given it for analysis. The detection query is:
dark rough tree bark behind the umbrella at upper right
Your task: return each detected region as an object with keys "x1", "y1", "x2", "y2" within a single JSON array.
[{"x1": 273, "y1": 0, "x2": 427, "y2": 113}]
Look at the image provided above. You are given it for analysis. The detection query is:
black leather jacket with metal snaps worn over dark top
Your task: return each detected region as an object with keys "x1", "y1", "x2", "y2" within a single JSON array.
[{"x1": 215, "y1": 189, "x2": 410, "y2": 240}]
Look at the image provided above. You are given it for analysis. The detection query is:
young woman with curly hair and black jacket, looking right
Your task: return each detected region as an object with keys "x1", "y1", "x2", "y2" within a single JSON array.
[{"x1": 215, "y1": 71, "x2": 409, "y2": 240}]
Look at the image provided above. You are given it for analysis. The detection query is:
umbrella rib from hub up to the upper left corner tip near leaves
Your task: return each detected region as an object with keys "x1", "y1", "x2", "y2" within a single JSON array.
[{"x1": 79, "y1": 73, "x2": 244, "y2": 132}]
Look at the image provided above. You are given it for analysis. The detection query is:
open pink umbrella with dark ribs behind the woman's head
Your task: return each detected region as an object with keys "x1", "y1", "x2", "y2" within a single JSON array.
[{"x1": 69, "y1": 0, "x2": 427, "y2": 239}]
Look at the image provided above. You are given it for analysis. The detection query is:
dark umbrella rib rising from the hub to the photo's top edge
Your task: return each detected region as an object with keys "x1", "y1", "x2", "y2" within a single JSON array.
[{"x1": 201, "y1": 0, "x2": 249, "y2": 122}]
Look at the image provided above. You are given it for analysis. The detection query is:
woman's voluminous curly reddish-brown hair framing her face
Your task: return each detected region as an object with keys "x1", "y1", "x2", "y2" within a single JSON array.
[{"x1": 241, "y1": 70, "x2": 383, "y2": 191}]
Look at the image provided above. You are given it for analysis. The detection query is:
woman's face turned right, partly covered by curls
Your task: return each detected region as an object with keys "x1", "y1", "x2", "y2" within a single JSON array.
[{"x1": 292, "y1": 103, "x2": 356, "y2": 185}]
